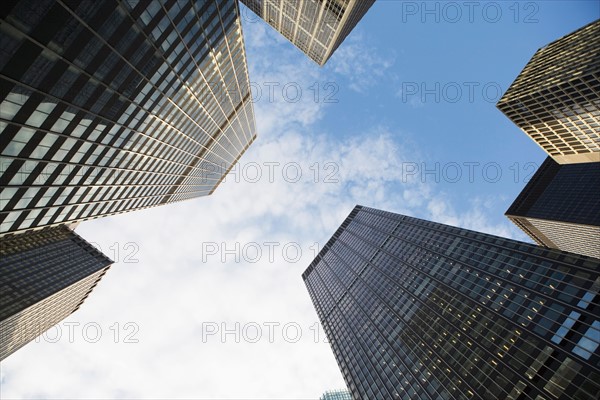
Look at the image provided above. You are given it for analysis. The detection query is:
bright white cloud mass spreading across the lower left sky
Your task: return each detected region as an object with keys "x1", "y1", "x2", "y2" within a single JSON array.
[{"x1": 2, "y1": 121, "x2": 524, "y2": 399}]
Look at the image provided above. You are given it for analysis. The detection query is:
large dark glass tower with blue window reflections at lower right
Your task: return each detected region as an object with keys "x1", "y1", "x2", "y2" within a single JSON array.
[{"x1": 302, "y1": 206, "x2": 600, "y2": 400}]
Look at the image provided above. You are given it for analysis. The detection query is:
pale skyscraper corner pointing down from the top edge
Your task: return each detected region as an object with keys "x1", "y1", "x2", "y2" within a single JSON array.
[{"x1": 241, "y1": 0, "x2": 375, "y2": 66}]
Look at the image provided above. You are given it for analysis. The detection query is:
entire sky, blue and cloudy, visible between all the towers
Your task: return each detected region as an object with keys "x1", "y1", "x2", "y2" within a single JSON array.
[{"x1": 0, "y1": 1, "x2": 599, "y2": 399}]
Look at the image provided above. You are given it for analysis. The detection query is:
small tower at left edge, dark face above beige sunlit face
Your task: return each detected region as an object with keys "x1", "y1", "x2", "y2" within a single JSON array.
[{"x1": 0, "y1": 226, "x2": 112, "y2": 360}]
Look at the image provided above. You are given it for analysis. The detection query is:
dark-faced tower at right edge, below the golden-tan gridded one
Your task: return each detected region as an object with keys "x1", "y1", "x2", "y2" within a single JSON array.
[{"x1": 506, "y1": 157, "x2": 600, "y2": 258}]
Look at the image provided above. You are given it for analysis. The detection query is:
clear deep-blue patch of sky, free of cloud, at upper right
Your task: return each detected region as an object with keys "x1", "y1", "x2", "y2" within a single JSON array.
[{"x1": 324, "y1": 1, "x2": 600, "y2": 220}]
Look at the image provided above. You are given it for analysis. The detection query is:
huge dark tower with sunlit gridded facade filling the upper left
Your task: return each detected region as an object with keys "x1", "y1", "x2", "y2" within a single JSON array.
[{"x1": 0, "y1": 0, "x2": 255, "y2": 234}]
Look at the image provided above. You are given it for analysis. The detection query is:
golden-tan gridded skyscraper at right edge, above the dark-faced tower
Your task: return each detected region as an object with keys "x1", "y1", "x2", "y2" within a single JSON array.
[{"x1": 497, "y1": 20, "x2": 600, "y2": 164}]
